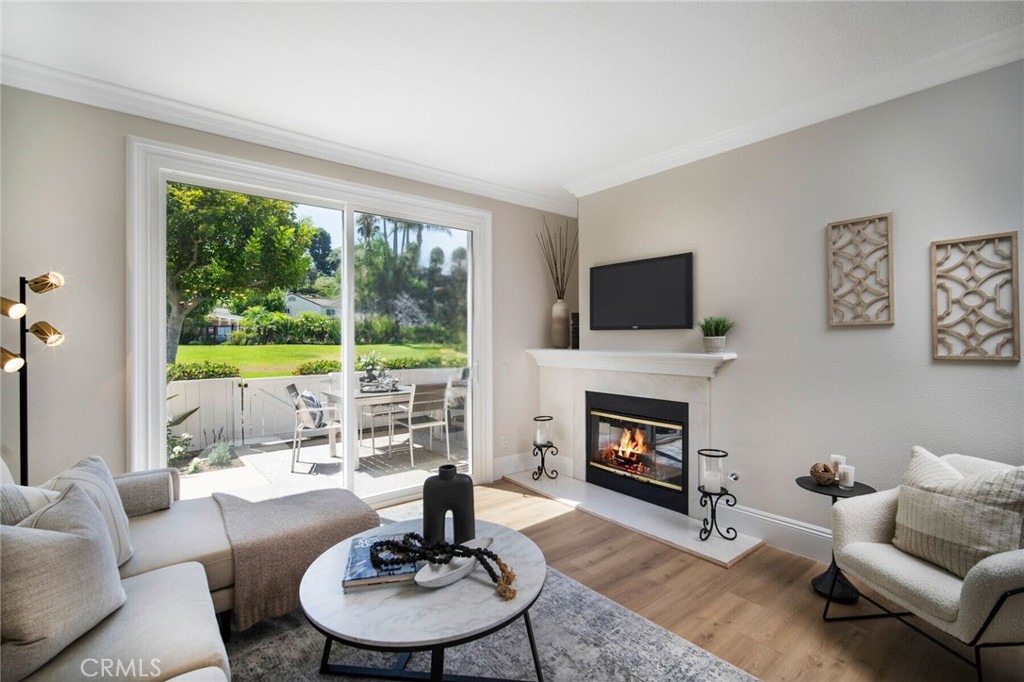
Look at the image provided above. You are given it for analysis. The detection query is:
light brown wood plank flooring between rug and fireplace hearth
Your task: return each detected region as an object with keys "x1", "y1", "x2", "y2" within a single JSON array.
[{"x1": 475, "y1": 481, "x2": 1024, "y2": 682}]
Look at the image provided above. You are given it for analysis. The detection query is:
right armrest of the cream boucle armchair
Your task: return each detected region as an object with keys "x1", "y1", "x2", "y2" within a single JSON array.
[{"x1": 959, "y1": 549, "x2": 1024, "y2": 641}]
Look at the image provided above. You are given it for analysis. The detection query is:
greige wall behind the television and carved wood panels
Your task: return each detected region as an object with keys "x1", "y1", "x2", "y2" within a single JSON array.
[{"x1": 580, "y1": 62, "x2": 1024, "y2": 526}]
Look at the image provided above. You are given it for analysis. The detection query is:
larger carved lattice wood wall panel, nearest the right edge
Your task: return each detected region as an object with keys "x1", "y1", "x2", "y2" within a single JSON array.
[{"x1": 932, "y1": 232, "x2": 1021, "y2": 363}]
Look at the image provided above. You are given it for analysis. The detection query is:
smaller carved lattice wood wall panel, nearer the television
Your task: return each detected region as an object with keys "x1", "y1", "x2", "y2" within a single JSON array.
[{"x1": 825, "y1": 213, "x2": 896, "y2": 327}]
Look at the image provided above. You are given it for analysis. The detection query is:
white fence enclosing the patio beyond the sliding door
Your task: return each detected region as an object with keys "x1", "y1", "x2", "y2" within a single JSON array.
[{"x1": 167, "y1": 368, "x2": 462, "y2": 450}]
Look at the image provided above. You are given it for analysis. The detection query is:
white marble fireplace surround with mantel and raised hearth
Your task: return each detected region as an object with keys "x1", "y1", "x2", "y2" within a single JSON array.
[{"x1": 516, "y1": 349, "x2": 761, "y2": 566}]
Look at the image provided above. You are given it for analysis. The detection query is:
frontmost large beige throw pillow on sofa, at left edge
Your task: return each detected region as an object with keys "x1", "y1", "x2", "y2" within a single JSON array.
[{"x1": 0, "y1": 484, "x2": 125, "y2": 680}]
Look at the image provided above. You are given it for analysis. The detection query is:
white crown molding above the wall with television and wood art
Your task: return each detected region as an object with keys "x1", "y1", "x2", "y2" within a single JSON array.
[{"x1": 563, "y1": 26, "x2": 1024, "y2": 198}]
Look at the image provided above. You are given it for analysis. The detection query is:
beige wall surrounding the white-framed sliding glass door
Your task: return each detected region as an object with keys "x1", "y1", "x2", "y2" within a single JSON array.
[{"x1": 0, "y1": 87, "x2": 577, "y2": 482}]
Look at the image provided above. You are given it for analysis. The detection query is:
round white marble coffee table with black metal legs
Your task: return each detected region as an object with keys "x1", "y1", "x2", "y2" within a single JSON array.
[{"x1": 299, "y1": 519, "x2": 547, "y2": 682}]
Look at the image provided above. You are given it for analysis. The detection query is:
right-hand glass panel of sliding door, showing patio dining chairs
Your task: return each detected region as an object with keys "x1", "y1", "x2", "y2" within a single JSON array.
[{"x1": 353, "y1": 212, "x2": 472, "y2": 499}]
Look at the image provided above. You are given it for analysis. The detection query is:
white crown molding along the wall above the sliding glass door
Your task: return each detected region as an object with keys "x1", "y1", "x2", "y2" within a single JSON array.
[{"x1": 0, "y1": 55, "x2": 577, "y2": 218}]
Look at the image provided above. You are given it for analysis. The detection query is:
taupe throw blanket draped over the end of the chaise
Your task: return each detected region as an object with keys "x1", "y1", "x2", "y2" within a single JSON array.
[{"x1": 213, "y1": 488, "x2": 380, "y2": 630}]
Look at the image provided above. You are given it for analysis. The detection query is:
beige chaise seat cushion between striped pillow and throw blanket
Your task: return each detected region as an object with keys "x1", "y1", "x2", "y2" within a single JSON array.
[{"x1": 121, "y1": 491, "x2": 234, "y2": 592}]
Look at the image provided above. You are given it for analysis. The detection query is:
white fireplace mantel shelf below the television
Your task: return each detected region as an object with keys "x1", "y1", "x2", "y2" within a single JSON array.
[{"x1": 526, "y1": 348, "x2": 736, "y2": 379}]
